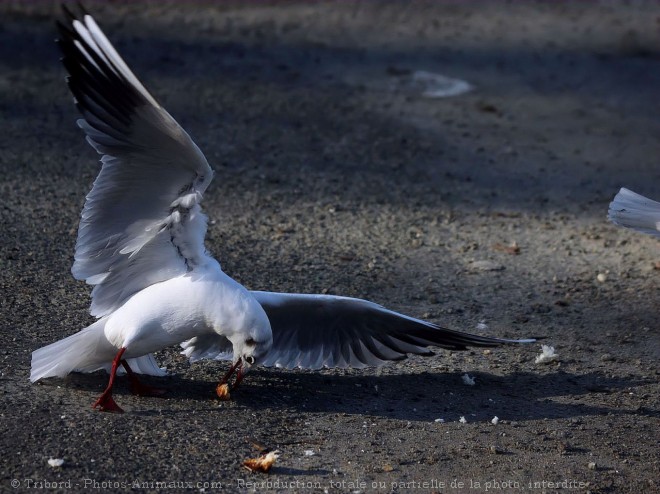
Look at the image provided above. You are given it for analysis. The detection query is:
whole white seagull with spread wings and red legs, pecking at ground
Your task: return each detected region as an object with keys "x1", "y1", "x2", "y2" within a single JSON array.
[{"x1": 30, "y1": 8, "x2": 535, "y2": 413}]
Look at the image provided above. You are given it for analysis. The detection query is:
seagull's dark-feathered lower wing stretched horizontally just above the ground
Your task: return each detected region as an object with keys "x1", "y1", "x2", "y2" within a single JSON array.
[{"x1": 251, "y1": 292, "x2": 535, "y2": 369}]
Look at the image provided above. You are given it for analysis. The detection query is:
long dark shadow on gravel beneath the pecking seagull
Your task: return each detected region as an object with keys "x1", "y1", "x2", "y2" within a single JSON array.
[{"x1": 42, "y1": 369, "x2": 660, "y2": 422}]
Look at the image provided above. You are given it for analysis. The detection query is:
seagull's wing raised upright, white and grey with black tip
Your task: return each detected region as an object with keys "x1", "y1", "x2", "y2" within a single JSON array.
[{"x1": 58, "y1": 9, "x2": 213, "y2": 317}]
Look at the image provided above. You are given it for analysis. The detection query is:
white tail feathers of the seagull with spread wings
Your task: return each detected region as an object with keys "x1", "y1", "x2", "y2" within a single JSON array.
[{"x1": 30, "y1": 318, "x2": 167, "y2": 382}]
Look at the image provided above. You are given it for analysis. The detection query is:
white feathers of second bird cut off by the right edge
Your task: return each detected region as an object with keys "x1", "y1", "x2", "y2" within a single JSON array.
[{"x1": 608, "y1": 189, "x2": 660, "y2": 236}]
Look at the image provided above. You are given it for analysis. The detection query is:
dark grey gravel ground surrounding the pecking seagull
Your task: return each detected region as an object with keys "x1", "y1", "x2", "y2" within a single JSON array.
[{"x1": 0, "y1": 1, "x2": 660, "y2": 493}]
